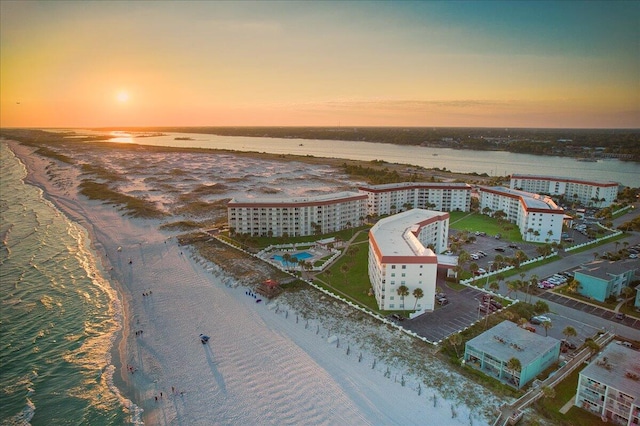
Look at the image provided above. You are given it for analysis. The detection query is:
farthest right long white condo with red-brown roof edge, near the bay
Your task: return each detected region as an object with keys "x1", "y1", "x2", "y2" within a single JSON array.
[{"x1": 509, "y1": 174, "x2": 618, "y2": 207}]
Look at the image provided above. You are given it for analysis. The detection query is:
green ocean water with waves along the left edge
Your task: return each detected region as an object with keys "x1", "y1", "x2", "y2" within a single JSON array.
[{"x1": 0, "y1": 143, "x2": 139, "y2": 425}]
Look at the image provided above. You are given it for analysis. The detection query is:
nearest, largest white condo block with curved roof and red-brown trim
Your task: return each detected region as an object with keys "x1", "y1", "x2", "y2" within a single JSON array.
[{"x1": 369, "y1": 209, "x2": 449, "y2": 311}]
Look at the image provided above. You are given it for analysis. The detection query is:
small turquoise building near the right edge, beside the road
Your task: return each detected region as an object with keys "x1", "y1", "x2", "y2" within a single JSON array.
[{"x1": 574, "y1": 260, "x2": 638, "y2": 302}]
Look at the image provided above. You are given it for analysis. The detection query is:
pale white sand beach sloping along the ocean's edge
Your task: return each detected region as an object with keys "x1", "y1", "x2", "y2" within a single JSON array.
[{"x1": 10, "y1": 143, "x2": 502, "y2": 425}]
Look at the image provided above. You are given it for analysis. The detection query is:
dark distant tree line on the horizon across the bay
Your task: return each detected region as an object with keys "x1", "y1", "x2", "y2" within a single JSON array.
[{"x1": 138, "y1": 127, "x2": 640, "y2": 161}]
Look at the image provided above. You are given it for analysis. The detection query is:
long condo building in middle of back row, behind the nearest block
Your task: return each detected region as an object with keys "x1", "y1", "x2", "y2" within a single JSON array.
[{"x1": 358, "y1": 182, "x2": 471, "y2": 216}]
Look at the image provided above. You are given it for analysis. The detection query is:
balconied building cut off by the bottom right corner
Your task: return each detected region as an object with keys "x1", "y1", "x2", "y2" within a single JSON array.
[{"x1": 575, "y1": 343, "x2": 640, "y2": 425}]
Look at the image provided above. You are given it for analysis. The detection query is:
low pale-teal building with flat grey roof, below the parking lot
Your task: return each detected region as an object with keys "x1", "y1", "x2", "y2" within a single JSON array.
[{"x1": 464, "y1": 321, "x2": 560, "y2": 389}]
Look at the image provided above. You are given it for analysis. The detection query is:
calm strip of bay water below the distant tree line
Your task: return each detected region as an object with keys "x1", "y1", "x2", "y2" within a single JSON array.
[{"x1": 66, "y1": 129, "x2": 640, "y2": 187}]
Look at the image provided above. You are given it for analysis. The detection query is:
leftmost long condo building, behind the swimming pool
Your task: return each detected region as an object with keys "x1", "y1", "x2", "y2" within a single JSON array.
[{"x1": 227, "y1": 192, "x2": 367, "y2": 237}]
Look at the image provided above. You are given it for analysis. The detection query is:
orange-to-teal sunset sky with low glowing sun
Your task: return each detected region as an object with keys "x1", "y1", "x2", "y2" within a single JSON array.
[{"x1": 0, "y1": 0, "x2": 640, "y2": 128}]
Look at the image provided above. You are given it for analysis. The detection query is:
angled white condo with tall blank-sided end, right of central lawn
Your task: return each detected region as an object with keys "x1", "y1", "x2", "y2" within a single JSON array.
[{"x1": 480, "y1": 187, "x2": 564, "y2": 243}]
